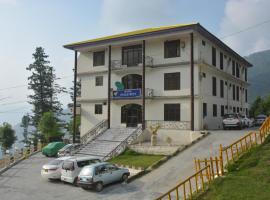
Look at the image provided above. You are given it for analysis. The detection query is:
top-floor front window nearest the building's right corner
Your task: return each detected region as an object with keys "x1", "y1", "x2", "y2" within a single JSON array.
[{"x1": 164, "y1": 40, "x2": 180, "y2": 58}]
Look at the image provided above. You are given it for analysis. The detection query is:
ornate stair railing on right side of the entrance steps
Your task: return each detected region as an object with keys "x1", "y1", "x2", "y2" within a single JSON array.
[{"x1": 102, "y1": 126, "x2": 143, "y2": 161}]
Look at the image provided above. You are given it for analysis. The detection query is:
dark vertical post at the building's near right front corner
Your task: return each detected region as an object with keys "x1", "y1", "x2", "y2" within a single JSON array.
[{"x1": 190, "y1": 33, "x2": 194, "y2": 131}]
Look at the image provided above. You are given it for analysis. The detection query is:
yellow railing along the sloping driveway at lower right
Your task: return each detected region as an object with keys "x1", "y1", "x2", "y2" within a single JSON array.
[{"x1": 156, "y1": 117, "x2": 270, "y2": 200}]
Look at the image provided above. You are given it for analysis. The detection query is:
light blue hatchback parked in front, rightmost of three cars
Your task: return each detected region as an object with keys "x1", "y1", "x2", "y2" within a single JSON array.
[{"x1": 78, "y1": 162, "x2": 130, "y2": 192}]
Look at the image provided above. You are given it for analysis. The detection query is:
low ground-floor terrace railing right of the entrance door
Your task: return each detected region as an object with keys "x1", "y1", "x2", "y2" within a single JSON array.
[{"x1": 146, "y1": 120, "x2": 190, "y2": 130}]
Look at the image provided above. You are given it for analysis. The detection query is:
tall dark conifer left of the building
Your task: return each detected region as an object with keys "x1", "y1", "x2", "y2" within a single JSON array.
[{"x1": 26, "y1": 47, "x2": 66, "y2": 128}]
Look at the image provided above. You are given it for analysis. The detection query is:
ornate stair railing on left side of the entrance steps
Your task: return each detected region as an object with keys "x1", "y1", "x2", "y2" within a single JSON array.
[{"x1": 80, "y1": 119, "x2": 108, "y2": 144}]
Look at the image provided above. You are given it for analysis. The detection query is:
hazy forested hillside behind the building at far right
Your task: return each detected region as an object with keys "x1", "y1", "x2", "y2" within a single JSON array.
[{"x1": 246, "y1": 50, "x2": 270, "y2": 102}]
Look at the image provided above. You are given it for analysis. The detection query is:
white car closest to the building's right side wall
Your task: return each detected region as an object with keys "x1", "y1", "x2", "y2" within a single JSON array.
[{"x1": 223, "y1": 113, "x2": 243, "y2": 130}]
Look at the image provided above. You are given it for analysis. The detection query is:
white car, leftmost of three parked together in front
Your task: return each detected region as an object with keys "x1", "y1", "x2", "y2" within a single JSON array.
[{"x1": 41, "y1": 156, "x2": 72, "y2": 180}]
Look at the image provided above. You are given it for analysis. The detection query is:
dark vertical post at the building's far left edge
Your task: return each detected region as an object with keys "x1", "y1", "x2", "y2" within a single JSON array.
[{"x1": 73, "y1": 50, "x2": 78, "y2": 143}]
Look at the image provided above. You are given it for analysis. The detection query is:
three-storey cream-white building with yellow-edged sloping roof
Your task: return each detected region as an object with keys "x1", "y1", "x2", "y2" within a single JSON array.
[{"x1": 64, "y1": 23, "x2": 252, "y2": 142}]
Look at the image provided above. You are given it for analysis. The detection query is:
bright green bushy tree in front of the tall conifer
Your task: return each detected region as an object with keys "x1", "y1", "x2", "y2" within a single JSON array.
[{"x1": 38, "y1": 111, "x2": 63, "y2": 142}]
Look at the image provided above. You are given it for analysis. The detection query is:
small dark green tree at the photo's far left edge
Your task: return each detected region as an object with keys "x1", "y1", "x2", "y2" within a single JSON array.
[{"x1": 0, "y1": 122, "x2": 17, "y2": 151}]
